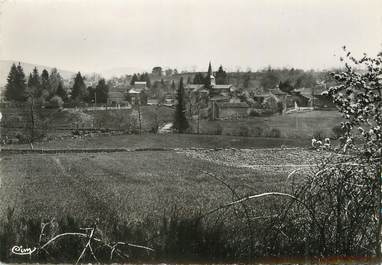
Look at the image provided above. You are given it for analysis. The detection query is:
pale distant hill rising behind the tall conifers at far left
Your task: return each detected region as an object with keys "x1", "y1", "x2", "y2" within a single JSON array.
[{"x1": 0, "y1": 60, "x2": 75, "y2": 86}]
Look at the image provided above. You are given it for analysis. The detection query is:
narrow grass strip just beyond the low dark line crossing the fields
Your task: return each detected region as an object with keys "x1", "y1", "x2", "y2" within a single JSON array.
[{"x1": 7, "y1": 134, "x2": 310, "y2": 149}]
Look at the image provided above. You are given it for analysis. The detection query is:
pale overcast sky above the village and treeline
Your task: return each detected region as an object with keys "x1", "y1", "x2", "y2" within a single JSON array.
[{"x1": 0, "y1": 0, "x2": 382, "y2": 72}]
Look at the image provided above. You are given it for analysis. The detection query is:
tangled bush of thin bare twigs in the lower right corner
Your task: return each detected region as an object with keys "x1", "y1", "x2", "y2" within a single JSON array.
[{"x1": 295, "y1": 155, "x2": 378, "y2": 256}]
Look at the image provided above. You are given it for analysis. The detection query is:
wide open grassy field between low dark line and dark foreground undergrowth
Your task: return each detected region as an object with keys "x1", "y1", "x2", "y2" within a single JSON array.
[{"x1": 0, "y1": 146, "x2": 320, "y2": 221}]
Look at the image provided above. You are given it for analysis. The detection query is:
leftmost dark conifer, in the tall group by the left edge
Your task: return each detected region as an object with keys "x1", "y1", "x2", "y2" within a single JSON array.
[{"x1": 5, "y1": 63, "x2": 27, "y2": 102}]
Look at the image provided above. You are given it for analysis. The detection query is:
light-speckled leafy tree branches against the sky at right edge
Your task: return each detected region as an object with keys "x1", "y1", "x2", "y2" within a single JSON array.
[{"x1": 328, "y1": 47, "x2": 382, "y2": 159}]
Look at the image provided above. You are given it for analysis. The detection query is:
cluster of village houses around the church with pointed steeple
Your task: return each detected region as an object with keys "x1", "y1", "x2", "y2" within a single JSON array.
[{"x1": 97, "y1": 60, "x2": 335, "y2": 120}]
